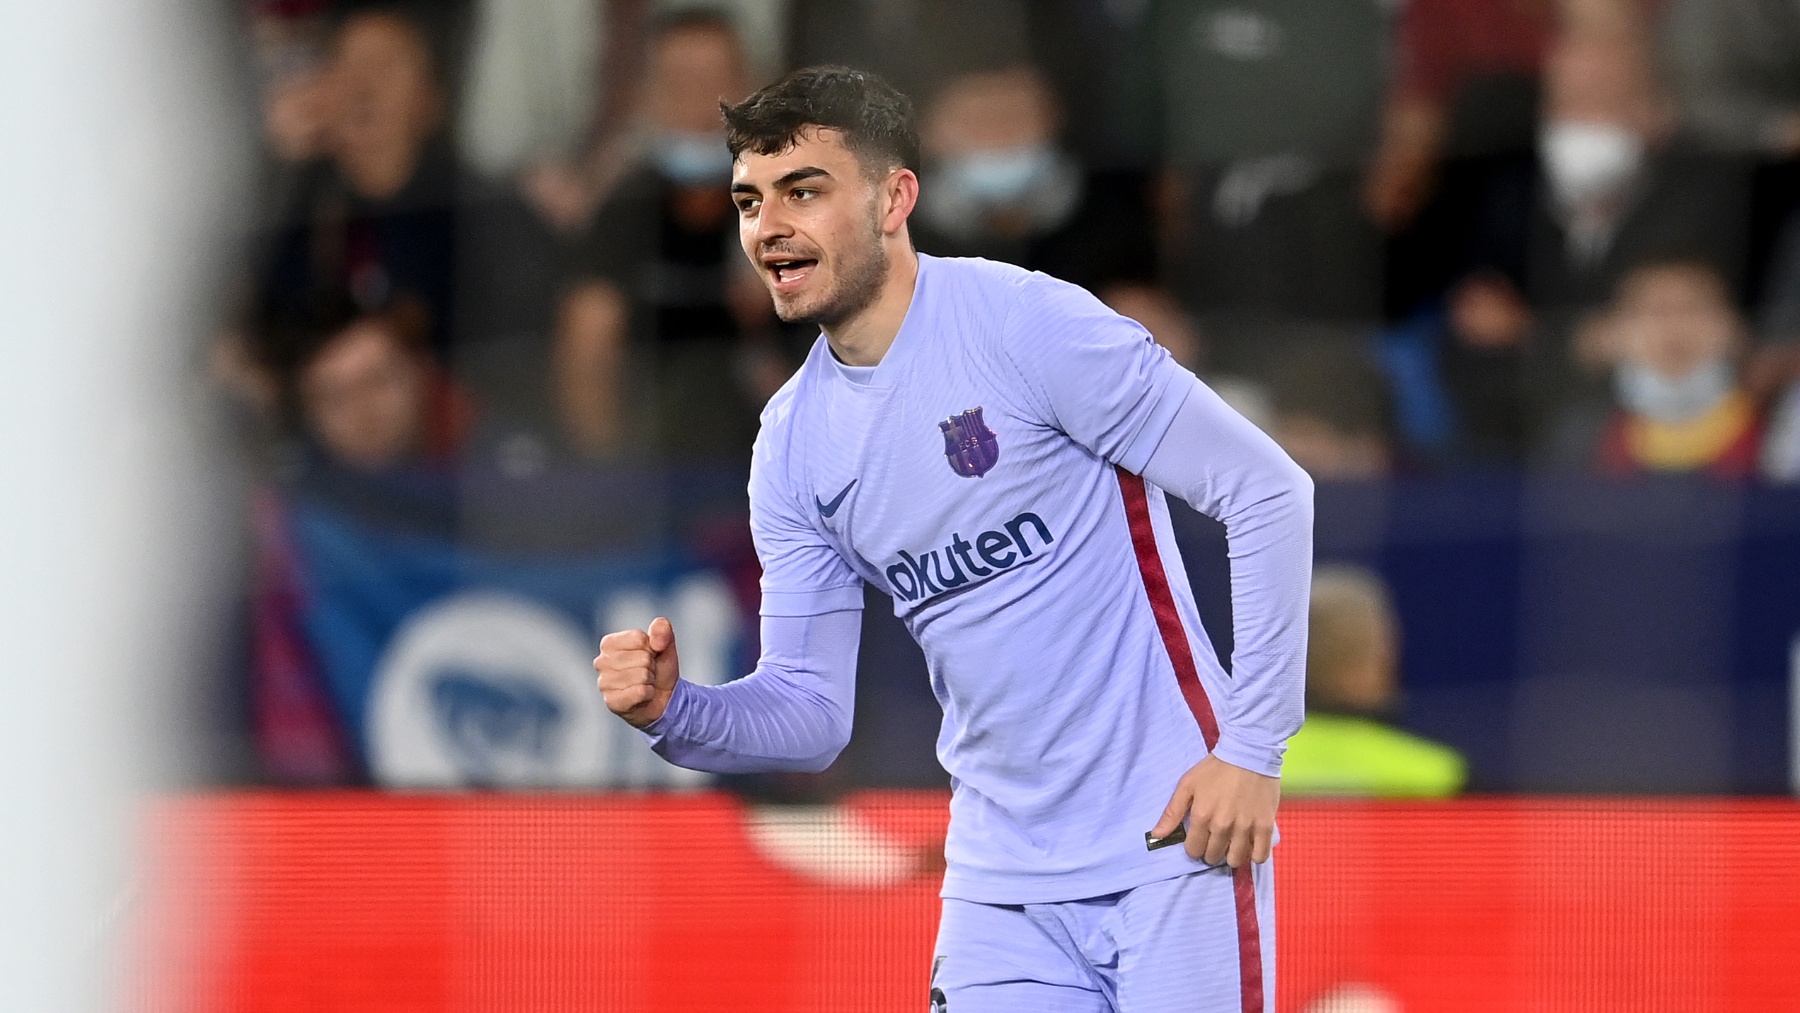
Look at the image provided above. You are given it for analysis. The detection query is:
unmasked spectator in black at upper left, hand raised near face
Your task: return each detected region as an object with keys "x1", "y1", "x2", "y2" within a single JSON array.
[{"x1": 241, "y1": 2, "x2": 563, "y2": 457}]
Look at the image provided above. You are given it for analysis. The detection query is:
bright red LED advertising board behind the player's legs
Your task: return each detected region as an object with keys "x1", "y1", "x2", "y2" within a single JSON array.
[{"x1": 131, "y1": 792, "x2": 1800, "y2": 1013}]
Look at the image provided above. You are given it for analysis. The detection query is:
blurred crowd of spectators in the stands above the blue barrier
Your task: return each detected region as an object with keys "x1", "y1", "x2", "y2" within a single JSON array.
[{"x1": 212, "y1": 0, "x2": 1800, "y2": 482}]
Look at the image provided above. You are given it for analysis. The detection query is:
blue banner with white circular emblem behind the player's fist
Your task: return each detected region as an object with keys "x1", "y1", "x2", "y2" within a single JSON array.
[{"x1": 259, "y1": 495, "x2": 745, "y2": 788}]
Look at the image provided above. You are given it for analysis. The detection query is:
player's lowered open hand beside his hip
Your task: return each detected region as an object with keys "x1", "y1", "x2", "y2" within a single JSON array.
[{"x1": 1150, "y1": 756, "x2": 1282, "y2": 869}]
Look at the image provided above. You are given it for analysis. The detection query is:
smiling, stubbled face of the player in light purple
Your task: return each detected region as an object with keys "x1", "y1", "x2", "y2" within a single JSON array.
[{"x1": 731, "y1": 130, "x2": 905, "y2": 327}]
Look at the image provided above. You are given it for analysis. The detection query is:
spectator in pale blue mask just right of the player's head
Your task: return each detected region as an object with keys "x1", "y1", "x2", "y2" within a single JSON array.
[{"x1": 914, "y1": 65, "x2": 1156, "y2": 291}]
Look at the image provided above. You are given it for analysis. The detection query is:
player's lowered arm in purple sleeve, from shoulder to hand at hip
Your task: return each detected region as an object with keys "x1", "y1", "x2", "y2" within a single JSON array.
[{"x1": 1004, "y1": 275, "x2": 1312, "y2": 865}]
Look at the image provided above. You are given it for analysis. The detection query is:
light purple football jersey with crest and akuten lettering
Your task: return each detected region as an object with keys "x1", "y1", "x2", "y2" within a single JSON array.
[{"x1": 657, "y1": 255, "x2": 1310, "y2": 903}]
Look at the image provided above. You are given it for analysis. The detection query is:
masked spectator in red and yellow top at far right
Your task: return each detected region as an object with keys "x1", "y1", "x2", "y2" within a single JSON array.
[{"x1": 1597, "y1": 261, "x2": 1762, "y2": 479}]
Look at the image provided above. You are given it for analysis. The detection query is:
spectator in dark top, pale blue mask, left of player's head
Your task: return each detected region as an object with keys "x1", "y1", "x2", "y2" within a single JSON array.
[{"x1": 554, "y1": 11, "x2": 787, "y2": 459}]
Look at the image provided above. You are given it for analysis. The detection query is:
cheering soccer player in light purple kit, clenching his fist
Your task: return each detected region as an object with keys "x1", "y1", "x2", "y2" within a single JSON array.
[{"x1": 594, "y1": 67, "x2": 1312, "y2": 1013}]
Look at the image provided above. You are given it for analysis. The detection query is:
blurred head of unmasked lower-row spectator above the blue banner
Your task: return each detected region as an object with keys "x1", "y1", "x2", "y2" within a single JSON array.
[{"x1": 277, "y1": 300, "x2": 473, "y2": 471}]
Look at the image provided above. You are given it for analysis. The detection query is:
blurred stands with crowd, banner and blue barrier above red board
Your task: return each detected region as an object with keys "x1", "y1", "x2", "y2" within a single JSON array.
[{"x1": 217, "y1": 0, "x2": 1800, "y2": 801}]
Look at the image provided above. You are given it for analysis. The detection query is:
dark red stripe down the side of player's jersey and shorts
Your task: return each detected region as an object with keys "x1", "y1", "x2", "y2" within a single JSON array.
[{"x1": 1118, "y1": 468, "x2": 1264, "y2": 1013}]
